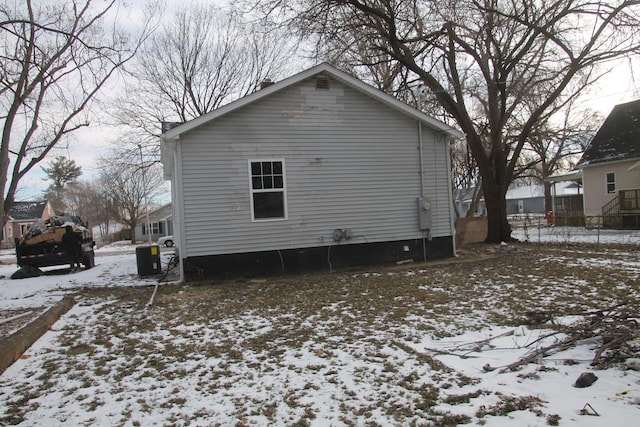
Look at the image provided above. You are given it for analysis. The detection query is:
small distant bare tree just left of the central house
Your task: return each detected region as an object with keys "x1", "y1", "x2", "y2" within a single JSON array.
[{"x1": 100, "y1": 152, "x2": 164, "y2": 243}]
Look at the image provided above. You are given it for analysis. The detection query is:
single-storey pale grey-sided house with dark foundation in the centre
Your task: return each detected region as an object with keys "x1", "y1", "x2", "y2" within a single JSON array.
[{"x1": 162, "y1": 63, "x2": 462, "y2": 280}]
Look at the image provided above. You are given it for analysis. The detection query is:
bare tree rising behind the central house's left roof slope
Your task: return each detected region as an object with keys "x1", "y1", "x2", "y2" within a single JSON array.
[{"x1": 114, "y1": 3, "x2": 291, "y2": 161}]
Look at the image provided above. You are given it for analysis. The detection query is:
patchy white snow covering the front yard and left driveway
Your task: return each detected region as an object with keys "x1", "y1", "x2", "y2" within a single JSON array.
[{"x1": 0, "y1": 236, "x2": 640, "y2": 427}]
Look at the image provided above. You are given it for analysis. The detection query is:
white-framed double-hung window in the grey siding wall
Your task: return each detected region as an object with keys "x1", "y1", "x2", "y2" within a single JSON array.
[{"x1": 249, "y1": 159, "x2": 287, "y2": 221}]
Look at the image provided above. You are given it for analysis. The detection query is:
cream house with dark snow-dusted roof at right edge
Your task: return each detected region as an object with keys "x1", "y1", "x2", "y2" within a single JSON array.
[{"x1": 577, "y1": 100, "x2": 640, "y2": 228}]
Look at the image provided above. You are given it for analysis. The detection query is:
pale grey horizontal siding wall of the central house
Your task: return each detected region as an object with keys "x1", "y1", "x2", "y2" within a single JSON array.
[{"x1": 174, "y1": 79, "x2": 453, "y2": 257}]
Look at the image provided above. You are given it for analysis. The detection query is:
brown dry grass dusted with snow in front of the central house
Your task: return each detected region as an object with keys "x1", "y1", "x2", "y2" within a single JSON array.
[{"x1": 0, "y1": 245, "x2": 640, "y2": 425}]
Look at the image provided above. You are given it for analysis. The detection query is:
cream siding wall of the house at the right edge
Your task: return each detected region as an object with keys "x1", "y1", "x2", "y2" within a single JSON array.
[{"x1": 582, "y1": 159, "x2": 640, "y2": 216}]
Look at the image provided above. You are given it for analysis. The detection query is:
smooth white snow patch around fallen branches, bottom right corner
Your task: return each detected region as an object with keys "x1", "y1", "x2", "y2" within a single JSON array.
[{"x1": 413, "y1": 327, "x2": 640, "y2": 426}]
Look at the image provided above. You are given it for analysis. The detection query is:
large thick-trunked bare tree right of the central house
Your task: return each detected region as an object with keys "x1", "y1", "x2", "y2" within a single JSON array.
[{"x1": 249, "y1": 0, "x2": 640, "y2": 242}]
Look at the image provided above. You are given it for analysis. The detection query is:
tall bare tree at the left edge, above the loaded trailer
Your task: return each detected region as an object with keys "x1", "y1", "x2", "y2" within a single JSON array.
[{"x1": 0, "y1": 0, "x2": 158, "y2": 227}]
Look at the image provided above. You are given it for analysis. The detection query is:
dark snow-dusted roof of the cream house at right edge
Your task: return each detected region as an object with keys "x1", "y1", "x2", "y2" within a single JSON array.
[{"x1": 577, "y1": 100, "x2": 640, "y2": 167}]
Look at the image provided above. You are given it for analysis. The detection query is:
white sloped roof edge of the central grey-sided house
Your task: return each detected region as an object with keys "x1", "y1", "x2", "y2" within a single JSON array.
[{"x1": 162, "y1": 62, "x2": 464, "y2": 140}]
